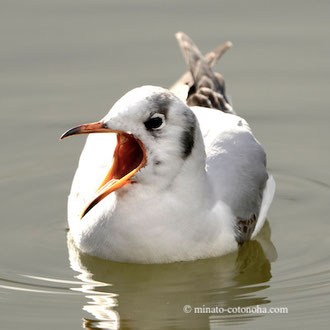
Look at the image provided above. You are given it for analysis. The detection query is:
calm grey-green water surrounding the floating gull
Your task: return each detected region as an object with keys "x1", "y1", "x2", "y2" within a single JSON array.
[{"x1": 0, "y1": 0, "x2": 330, "y2": 329}]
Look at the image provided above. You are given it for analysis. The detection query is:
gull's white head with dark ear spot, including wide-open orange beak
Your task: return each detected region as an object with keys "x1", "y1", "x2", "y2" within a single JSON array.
[{"x1": 62, "y1": 86, "x2": 205, "y2": 215}]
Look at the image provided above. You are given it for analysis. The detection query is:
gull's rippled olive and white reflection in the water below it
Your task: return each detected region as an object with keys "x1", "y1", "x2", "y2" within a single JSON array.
[{"x1": 68, "y1": 222, "x2": 277, "y2": 329}]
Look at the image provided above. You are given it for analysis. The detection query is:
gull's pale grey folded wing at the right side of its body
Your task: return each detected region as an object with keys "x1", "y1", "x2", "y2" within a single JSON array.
[{"x1": 207, "y1": 127, "x2": 268, "y2": 244}]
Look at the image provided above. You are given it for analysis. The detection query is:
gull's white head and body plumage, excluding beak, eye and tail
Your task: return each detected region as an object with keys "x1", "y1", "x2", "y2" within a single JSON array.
[{"x1": 68, "y1": 86, "x2": 275, "y2": 263}]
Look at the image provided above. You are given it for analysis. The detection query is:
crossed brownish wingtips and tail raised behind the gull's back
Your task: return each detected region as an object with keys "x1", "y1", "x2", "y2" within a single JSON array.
[{"x1": 171, "y1": 32, "x2": 235, "y2": 113}]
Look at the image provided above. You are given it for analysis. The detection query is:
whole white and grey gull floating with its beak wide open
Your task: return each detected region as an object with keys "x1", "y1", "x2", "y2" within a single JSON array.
[{"x1": 61, "y1": 32, "x2": 275, "y2": 263}]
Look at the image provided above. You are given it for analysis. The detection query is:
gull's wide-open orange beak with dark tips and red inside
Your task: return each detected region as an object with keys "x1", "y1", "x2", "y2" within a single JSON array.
[{"x1": 61, "y1": 122, "x2": 147, "y2": 217}]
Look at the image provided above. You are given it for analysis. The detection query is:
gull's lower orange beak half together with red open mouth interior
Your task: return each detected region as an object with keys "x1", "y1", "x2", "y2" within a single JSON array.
[{"x1": 82, "y1": 133, "x2": 146, "y2": 217}]
